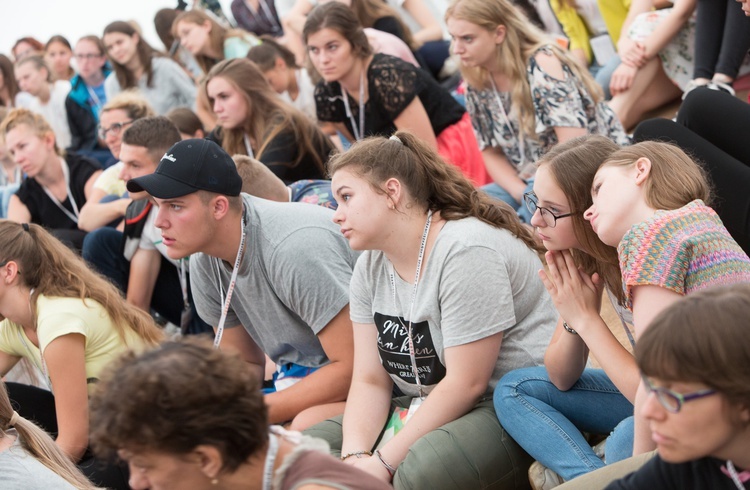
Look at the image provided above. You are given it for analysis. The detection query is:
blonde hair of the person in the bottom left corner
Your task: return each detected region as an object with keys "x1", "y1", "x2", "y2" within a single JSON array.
[{"x1": 0, "y1": 383, "x2": 97, "y2": 490}]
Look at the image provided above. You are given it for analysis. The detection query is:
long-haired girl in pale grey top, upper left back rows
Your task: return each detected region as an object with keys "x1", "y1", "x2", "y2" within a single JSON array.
[{"x1": 102, "y1": 21, "x2": 196, "y2": 115}]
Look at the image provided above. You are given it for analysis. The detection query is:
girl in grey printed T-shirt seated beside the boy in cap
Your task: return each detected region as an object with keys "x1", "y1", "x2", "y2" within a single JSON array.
[{"x1": 309, "y1": 131, "x2": 556, "y2": 489}]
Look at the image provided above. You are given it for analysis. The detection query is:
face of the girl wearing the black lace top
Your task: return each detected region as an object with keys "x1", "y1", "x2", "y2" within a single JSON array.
[{"x1": 307, "y1": 28, "x2": 356, "y2": 82}]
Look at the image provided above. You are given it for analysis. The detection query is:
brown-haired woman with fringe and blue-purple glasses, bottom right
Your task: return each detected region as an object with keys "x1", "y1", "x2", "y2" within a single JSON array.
[{"x1": 607, "y1": 284, "x2": 750, "y2": 490}]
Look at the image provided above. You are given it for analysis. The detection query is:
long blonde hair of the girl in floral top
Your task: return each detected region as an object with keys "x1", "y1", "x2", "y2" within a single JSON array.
[{"x1": 445, "y1": 0, "x2": 603, "y2": 139}]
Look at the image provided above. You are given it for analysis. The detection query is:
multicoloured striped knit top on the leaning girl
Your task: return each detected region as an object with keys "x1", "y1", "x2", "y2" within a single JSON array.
[{"x1": 617, "y1": 199, "x2": 750, "y2": 309}]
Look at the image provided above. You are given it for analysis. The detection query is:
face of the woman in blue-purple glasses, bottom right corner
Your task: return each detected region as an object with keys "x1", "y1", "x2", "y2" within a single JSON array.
[{"x1": 642, "y1": 378, "x2": 750, "y2": 463}]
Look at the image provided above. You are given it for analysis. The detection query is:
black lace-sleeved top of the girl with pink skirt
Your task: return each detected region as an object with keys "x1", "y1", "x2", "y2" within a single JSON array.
[{"x1": 315, "y1": 54, "x2": 465, "y2": 136}]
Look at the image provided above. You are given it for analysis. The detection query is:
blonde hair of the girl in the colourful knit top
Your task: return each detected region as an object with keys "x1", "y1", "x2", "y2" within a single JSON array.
[{"x1": 601, "y1": 141, "x2": 712, "y2": 210}]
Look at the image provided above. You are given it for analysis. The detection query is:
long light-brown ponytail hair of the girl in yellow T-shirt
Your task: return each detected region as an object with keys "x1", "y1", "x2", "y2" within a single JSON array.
[{"x1": 0, "y1": 220, "x2": 164, "y2": 345}]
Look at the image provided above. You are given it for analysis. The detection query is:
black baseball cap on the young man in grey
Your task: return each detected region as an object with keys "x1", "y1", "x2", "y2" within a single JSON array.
[{"x1": 127, "y1": 139, "x2": 242, "y2": 199}]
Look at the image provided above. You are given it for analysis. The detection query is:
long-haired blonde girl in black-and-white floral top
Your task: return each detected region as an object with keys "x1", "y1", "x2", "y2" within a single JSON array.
[{"x1": 446, "y1": 0, "x2": 629, "y2": 218}]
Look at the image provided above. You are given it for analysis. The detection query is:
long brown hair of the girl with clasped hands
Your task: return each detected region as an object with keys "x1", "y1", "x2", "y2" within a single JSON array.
[{"x1": 538, "y1": 135, "x2": 625, "y2": 305}]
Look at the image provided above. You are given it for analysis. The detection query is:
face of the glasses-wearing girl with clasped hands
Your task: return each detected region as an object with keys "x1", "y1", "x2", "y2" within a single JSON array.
[{"x1": 531, "y1": 165, "x2": 581, "y2": 250}]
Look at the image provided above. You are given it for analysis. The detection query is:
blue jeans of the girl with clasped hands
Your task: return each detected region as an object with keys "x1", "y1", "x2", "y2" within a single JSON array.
[{"x1": 494, "y1": 366, "x2": 633, "y2": 481}]
